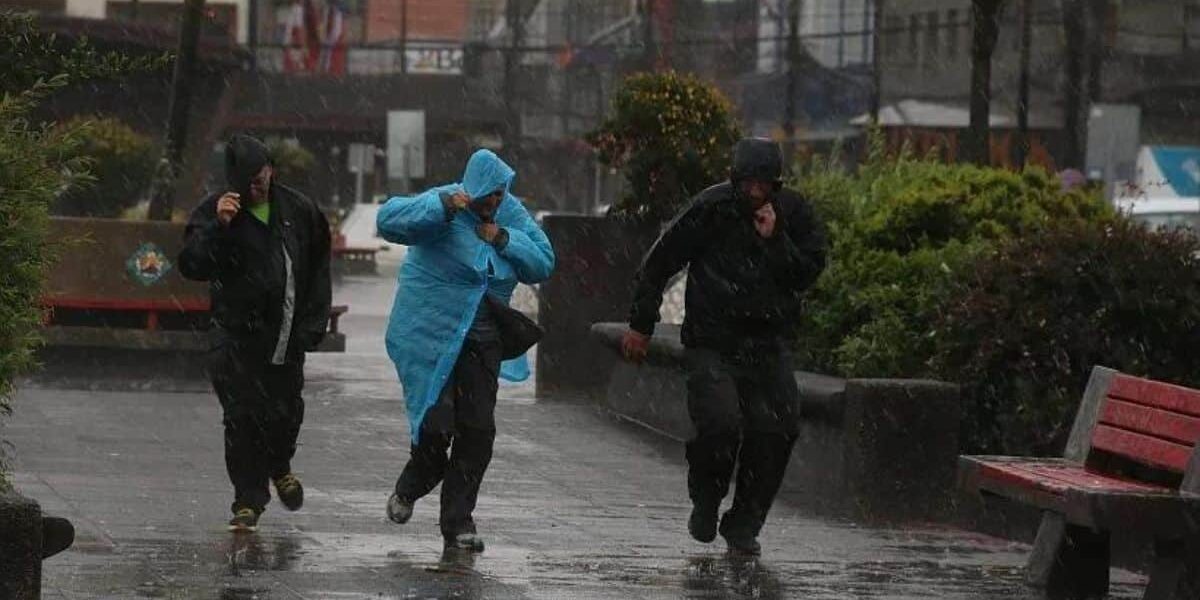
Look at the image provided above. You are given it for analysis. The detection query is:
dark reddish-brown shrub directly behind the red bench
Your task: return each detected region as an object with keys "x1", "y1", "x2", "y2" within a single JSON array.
[{"x1": 935, "y1": 218, "x2": 1200, "y2": 455}]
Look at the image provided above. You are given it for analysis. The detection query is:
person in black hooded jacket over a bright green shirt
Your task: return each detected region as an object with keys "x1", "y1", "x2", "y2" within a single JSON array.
[{"x1": 179, "y1": 136, "x2": 331, "y2": 530}]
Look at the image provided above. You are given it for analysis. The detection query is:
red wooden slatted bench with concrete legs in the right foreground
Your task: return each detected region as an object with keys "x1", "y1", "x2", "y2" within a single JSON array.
[{"x1": 959, "y1": 367, "x2": 1200, "y2": 600}]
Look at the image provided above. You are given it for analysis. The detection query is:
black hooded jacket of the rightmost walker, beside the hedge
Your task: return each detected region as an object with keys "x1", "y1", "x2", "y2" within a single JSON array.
[{"x1": 629, "y1": 139, "x2": 826, "y2": 349}]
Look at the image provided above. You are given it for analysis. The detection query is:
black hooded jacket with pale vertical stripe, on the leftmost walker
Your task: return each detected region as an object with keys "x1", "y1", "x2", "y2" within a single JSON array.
[{"x1": 179, "y1": 136, "x2": 331, "y2": 362}]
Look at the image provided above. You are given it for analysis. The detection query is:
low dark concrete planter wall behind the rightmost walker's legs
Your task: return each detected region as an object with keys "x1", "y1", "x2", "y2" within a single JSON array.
[{"x1": 592, "y1": 323, "x2": 960, "y2": 520}]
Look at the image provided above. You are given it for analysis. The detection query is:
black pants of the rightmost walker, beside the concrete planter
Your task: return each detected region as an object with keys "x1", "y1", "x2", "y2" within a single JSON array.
[{"x1": 686, "y1": 344, "x2": 799, "y2": 539}]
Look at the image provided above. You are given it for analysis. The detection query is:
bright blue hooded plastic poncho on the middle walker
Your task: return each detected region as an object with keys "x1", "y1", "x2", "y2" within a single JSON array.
[{"x1": 376, "y1": 150, "x2": 554, "y2": 444}]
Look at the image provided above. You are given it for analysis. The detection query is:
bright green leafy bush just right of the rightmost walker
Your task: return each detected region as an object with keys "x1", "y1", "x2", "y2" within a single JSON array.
[{"x1": 794, "y1": 143, "x2": 1114, "y2": 377}]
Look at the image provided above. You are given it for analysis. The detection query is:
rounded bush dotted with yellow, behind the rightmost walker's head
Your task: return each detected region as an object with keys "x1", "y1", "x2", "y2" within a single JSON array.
[{"x1": 587, "y1": 72, "x2": 740, "y2": 221}]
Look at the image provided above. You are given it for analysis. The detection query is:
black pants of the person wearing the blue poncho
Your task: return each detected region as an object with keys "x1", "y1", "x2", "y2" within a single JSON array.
[{"x1": 396, "y1": 340, "x2": 500, "y2": 539}]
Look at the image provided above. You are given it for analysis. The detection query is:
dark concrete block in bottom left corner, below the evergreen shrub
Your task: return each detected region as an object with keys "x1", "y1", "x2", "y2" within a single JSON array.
[{"x1": 0, "y1": 492, "x2": 42, "y2": 600}]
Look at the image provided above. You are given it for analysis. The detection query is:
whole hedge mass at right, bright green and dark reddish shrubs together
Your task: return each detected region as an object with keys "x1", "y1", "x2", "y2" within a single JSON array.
[{"x1": 792, "y1": 143, "x2": 1200, "y2": 455}]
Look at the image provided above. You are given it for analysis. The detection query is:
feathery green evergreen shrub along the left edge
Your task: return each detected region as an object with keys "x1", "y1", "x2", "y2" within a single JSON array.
[{"x1": 0, "y1": 10, "x2": 168, "y2": 487}]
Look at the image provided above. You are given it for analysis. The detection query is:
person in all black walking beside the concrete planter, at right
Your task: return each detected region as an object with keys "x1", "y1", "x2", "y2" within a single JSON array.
[{"x1": 622, "y1": 138, "x2": 826, "y2": 554}]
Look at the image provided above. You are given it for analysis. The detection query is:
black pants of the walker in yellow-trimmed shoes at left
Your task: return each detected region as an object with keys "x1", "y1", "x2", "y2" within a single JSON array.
[{"x1": 209, "y1": 342, "x2": 304, "y2": 512}]
